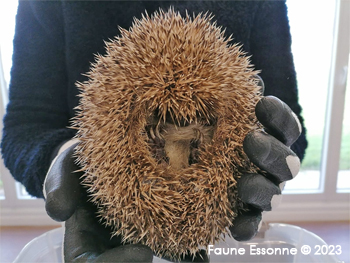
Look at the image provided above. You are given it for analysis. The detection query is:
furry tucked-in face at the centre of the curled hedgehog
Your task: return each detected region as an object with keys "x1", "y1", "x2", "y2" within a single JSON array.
[{"x1": 146, "y1": 92, "x2": 216, "y2": 170}]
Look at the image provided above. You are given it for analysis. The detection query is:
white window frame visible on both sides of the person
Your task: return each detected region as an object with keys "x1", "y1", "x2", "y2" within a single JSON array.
[{"x1": 0, "y1": 0, "x2": 350, "y2": 225}]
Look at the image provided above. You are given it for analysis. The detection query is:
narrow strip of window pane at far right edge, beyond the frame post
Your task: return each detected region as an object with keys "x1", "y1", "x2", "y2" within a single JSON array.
[{"x1": 337, "y1": 56, "x2": 350, "y2": 193}]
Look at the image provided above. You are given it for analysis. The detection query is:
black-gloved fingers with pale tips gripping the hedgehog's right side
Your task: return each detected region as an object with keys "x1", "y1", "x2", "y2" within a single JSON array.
[{"x1": 230, "y1": 96, "x2": 301, "y2": 241}]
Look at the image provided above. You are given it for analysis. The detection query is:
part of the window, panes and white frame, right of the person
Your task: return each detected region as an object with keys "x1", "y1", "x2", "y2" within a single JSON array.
[{"x1": 265, "y1": 0, "x2": 350, "y2": 221}]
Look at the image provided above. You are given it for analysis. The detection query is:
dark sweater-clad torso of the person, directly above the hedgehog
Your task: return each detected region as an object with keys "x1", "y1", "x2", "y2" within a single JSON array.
[{"x1": 62, "y1": 1, "x2": 257, "y2": 116}]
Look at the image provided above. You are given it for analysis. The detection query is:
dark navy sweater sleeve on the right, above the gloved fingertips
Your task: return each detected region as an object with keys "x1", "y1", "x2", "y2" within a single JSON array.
[{"x1": 250, "y1": 1, "x2": 307, "y2": 160}]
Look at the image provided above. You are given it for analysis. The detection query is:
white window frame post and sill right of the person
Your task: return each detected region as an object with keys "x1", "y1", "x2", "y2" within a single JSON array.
[{"x1": 264, "y1": 0, "x2": 350, "y2": 224}]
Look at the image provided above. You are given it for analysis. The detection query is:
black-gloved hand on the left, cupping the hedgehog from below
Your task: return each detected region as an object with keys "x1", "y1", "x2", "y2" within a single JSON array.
[{"x1": 44, "y1": 144, "x2": 153, "y2": 262}]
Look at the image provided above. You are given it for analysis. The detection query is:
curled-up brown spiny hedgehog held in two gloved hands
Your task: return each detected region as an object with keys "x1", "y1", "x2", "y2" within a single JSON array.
[{"x1": 73, "y1": 8, "x2": 261, "y2": 259}]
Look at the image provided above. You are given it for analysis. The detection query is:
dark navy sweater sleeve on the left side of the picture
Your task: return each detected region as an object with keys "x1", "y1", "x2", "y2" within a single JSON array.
[{"x1": 1, "y1": 1, "x2": 74, "y2": 197}]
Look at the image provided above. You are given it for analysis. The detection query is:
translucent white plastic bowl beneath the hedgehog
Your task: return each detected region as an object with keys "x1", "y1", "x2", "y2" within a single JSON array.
[{"x1": 14, "y1": 224, "x2": 339, "y2": 263}]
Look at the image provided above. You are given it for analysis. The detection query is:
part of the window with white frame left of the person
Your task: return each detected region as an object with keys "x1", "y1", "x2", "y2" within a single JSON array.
[{"x1": 0, "y1": 1, "x2": 56, "y2": 225}]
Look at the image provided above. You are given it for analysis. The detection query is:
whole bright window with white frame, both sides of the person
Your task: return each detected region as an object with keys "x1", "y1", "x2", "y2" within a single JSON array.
[{"x1": 0, "y1": 0, "x2": 350, "y2": 227}]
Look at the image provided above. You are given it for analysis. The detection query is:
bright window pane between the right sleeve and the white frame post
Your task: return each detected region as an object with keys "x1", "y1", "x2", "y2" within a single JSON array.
[{"x1": 285, "y1": 0, "x2": 336, "y2": 193}]
